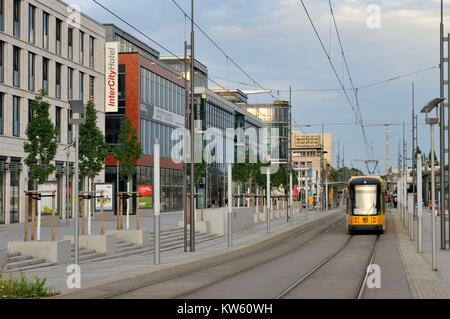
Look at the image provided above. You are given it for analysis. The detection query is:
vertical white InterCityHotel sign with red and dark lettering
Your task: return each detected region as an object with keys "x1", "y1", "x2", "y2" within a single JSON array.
[{"x1": 105, "y1": 42, "x2": 119, "y2": 112}]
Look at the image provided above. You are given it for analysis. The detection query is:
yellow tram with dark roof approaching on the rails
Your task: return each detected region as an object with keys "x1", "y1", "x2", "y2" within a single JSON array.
[{"x1": 346, "y1": 176, "x2": 386, "y2": 233}]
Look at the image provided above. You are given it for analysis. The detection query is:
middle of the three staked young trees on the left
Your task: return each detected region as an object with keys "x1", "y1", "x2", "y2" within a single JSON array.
[{"x1": 78, "y1": 101, "x2": 109, "y2": 198}]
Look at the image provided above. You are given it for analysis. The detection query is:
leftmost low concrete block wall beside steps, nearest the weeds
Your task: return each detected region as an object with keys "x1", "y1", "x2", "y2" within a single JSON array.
[{"x1": 8, "y1": 240, "x2": 70, "y2": 264}]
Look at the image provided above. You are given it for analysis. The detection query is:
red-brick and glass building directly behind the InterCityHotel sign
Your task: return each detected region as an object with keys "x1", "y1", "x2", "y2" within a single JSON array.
[{"x1": 104, "y1": 24, "x2": 185, "y2": 212}]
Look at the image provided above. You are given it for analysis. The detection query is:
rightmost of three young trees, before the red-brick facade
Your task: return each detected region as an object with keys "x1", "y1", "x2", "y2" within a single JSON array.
[{"x1": 114, "y1": 116, "x2": 142, "y2": 209}]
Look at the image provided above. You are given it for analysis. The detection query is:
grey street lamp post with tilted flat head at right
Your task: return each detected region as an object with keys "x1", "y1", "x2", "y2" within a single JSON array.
[{"x1": 421, "y1": 98, "x2": 445, "y2": 270}]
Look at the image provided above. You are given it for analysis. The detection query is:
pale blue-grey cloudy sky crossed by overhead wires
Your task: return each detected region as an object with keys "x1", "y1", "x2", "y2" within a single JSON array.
[{"x1": 69, "y1": 0, "x2": 450, "y2": 173}]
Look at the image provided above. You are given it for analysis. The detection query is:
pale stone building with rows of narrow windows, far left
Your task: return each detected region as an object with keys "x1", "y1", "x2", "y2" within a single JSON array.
[{"x1": 0, "y1": 0, "x2": 105, "y2": 224}]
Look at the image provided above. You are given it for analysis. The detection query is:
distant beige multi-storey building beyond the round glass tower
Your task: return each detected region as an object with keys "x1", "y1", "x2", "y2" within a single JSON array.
[{"x1": 291, "y1": 131, "x2": 333, "y2": 204}]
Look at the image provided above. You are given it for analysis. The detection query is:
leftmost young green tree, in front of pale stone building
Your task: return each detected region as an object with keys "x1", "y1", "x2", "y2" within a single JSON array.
[{"x1": 23, "y1": 90, "x2": 58, "y2": 188}]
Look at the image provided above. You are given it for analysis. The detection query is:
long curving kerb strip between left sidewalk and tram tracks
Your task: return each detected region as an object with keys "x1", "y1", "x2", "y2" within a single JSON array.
[{"x1": 52, "y1": 212, "x2": 339, "y2": 299}]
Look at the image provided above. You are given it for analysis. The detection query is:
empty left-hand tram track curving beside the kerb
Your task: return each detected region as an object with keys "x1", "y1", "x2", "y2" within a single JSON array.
[{"x1": 101, "y1": 214, "x2": 345, "y2": 299}]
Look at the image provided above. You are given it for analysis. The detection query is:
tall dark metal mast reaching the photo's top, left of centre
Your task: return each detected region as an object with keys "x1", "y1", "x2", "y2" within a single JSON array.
[{"x1": 190, "y1": 0, "x2": 196, "y2": 252}]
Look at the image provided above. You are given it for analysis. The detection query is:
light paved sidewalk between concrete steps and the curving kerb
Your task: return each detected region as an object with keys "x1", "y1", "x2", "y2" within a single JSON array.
[{"x1": 20, "y1": 210, "x2": 337, "y2": 294}]
